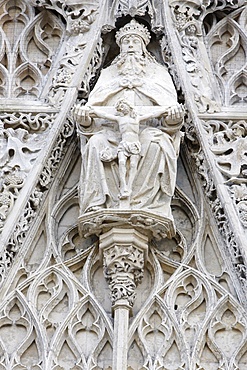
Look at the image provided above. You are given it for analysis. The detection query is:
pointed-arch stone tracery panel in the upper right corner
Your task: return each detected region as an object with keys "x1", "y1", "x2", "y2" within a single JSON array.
[{"x1": 204, "y1": 7, "x2": 247, "y2": 106}]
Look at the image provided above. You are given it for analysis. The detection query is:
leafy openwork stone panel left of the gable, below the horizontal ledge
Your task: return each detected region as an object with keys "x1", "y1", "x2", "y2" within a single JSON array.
[{"x1": 0, "y1": 112, "x2": 55, "y2": 230}]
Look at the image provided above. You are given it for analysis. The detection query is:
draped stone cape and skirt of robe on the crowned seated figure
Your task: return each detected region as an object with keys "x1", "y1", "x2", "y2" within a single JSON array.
[{"x1": 80, "y1": 53, "x2": 181, "y2": 218}]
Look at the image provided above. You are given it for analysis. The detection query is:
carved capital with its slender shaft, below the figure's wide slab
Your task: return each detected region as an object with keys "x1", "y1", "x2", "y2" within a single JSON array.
[{"x1": 100, "y1": 227, "x2": 148, "y2": 370}]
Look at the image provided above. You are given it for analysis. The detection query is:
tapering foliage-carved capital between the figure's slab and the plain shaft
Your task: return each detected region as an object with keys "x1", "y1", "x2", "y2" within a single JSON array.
[{"x1": 99, "y1": 227, "x2": 148, "y2": 314}]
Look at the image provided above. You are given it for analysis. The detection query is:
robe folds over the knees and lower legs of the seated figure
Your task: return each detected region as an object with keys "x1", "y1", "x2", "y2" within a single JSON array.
[{"x1": 80, "y1": 127, "x2": 180, "y2": 217}]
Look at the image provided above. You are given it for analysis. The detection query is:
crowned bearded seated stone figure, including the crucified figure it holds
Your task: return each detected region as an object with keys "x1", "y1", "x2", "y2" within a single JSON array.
[{"x1": 75, "y1": 20, "x2": 184, "y2": 217}]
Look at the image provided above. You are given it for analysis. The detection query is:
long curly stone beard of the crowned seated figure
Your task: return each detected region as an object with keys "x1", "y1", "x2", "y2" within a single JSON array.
[{"x1": 115, "y1": 53, "x2": 147, "y2": 77}]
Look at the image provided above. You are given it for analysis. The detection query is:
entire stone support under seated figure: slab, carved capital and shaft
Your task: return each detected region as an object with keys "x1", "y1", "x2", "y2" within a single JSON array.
[{"x1": 79, "y1": 209, "x2": 175, "y2": 370}]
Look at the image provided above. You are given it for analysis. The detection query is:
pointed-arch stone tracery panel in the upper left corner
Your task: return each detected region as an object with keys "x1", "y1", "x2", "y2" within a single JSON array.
[{"x1": 0, "y1": 0, "x2": 64, "y2": 99}]
